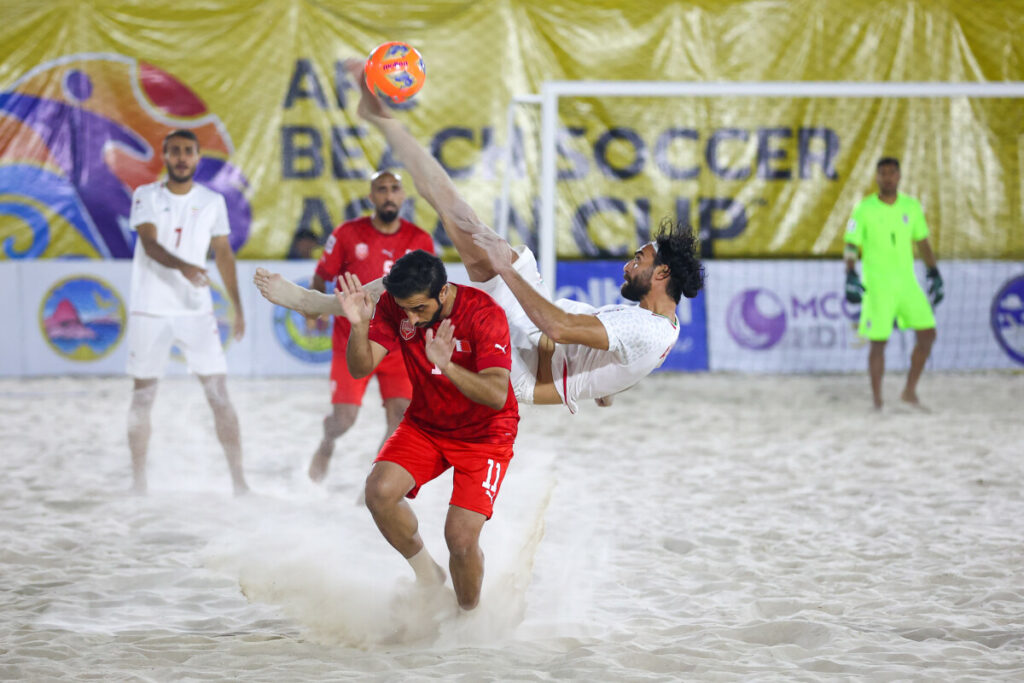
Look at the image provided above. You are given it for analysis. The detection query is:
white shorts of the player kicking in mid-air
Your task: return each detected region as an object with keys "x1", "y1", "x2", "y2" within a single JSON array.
[{"x1": 473, "y1": 246, "x2": 551, "y2": 403}]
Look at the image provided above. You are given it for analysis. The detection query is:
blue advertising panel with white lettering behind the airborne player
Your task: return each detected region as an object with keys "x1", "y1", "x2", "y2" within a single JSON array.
[{"x1": 555, "y1": 261, "x2": 708, "y2": 372}]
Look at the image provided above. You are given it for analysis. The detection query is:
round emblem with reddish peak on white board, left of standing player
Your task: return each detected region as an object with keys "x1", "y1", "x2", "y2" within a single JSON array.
[{"x1": 39, "y1": 275, "x2": 125, "y2": 361}]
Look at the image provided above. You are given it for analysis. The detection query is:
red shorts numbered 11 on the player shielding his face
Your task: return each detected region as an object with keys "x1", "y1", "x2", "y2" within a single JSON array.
[{"x1": 374, "y1": 420, "x2": 512, "y2": 519}]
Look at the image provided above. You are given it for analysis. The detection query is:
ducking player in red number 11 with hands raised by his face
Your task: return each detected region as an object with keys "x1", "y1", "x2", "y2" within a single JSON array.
[{"x1": 337, "y1": 251, "x2": 519, "y2": 609}]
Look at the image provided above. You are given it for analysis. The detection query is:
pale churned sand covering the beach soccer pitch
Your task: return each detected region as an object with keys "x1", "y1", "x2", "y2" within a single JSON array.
[{"x1": 0, "y1": 373, "x2": 1024, "y2": 681}]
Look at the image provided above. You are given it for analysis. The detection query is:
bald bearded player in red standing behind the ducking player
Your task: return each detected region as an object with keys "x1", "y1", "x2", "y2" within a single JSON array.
[{"x1": 309, "y1": 171, "x2": 434, "y2": 481}]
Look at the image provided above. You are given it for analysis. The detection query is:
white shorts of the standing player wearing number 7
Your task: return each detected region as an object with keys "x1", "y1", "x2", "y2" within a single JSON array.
[{"x1": 127, "y1": 313, "x2": 227, "y2": 379}]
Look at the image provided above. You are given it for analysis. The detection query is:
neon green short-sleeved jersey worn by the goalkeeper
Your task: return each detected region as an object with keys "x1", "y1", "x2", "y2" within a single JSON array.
[{"x1": 844, "y1": 193, "x2": 928, "y2": 290}]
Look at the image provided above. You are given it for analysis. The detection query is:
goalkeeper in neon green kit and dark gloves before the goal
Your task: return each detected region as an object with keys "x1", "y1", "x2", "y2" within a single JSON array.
[{"x1": 843, "y1": 157, "x2": 944, "y2": 410}]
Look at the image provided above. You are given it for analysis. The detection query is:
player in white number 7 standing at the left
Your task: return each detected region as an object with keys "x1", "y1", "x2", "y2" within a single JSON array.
[{"x1": 128, "y1": 130, "x2": 249, "y2": 494}]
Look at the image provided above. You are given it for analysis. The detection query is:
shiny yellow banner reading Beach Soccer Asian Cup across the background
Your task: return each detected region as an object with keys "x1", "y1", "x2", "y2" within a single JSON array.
[{"x1": 0, "y1": 0, "x2": 1024, "y2": 258}]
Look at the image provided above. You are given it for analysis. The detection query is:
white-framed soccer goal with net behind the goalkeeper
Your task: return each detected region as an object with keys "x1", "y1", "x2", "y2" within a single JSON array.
[{"x1": 498, "y1": 81, "x2": 1024, "y2": 372}]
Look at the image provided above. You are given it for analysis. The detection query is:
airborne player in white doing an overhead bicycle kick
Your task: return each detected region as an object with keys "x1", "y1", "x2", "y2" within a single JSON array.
[{"x1": 255, "y1": 60, "x2": 703, "y2": 413}]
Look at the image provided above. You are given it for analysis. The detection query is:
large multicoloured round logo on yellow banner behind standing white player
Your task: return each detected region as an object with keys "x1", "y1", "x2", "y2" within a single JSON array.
[{"x1": 0, "y1": 54, "x2": 251, "y2": 259}]
